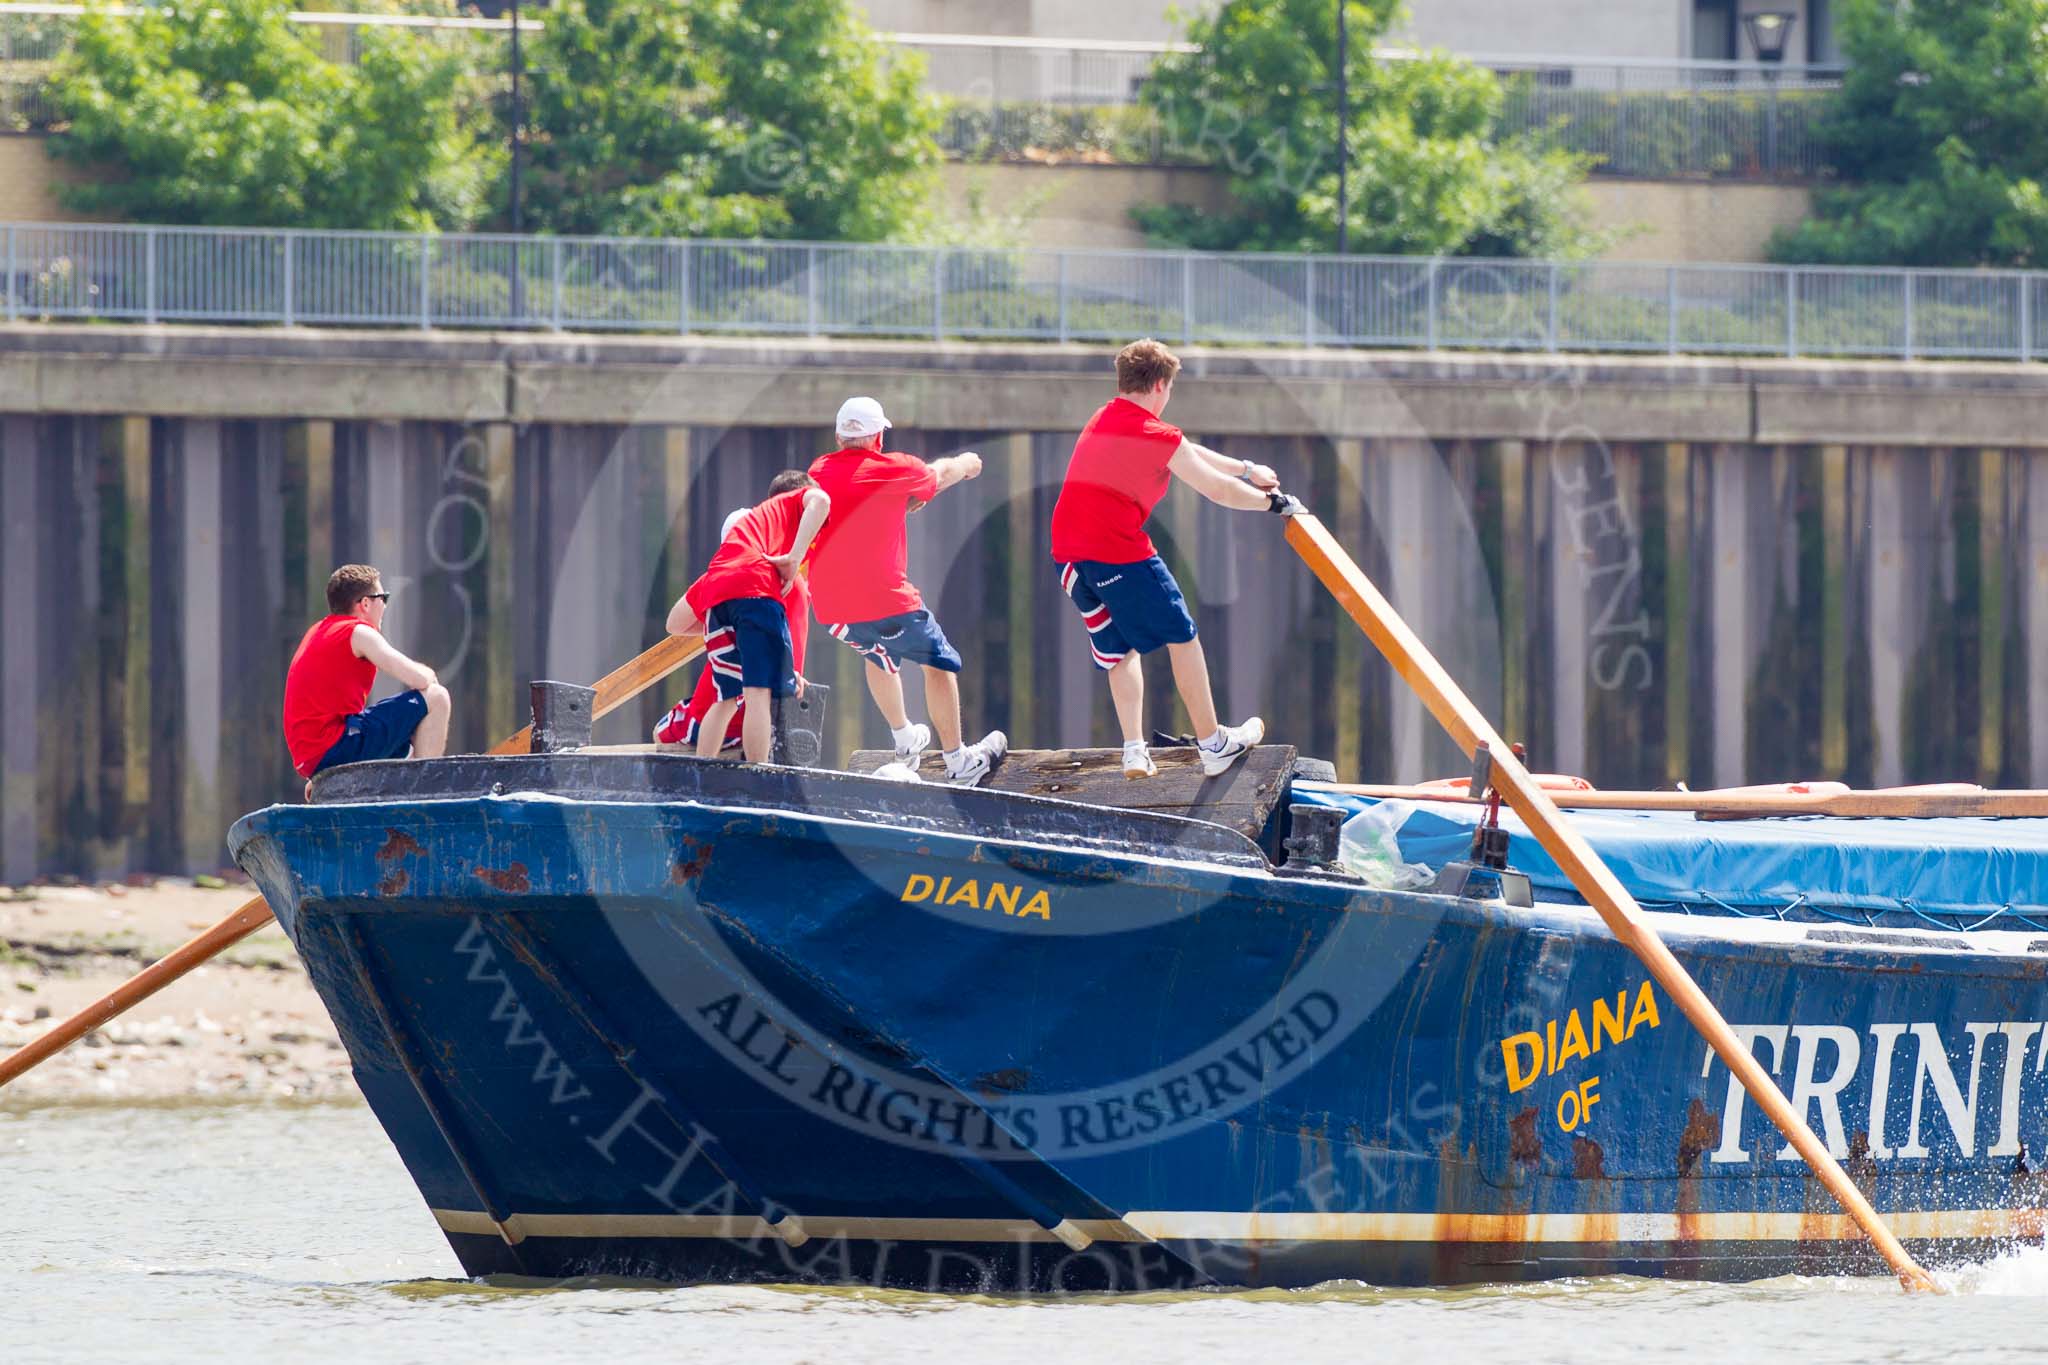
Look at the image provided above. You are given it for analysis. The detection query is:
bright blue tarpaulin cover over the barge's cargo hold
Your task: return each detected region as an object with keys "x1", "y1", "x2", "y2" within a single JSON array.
[{"x1": 1294, "y1": 782, "x2": 2048, "y2": 927}]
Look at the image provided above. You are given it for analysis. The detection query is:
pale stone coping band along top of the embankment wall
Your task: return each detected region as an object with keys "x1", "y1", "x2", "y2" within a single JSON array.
[{"x1": 0, "y1": 323, "x2": 2048, "y2": 446}]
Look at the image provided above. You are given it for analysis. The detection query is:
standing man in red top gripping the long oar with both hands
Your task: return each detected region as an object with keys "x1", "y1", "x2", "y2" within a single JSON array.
[{"x1": 1053, "y1": 338, "x2": 1300, "y2": 778}]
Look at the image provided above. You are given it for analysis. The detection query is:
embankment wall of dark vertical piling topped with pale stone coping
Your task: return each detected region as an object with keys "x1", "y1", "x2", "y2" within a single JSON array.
[{"x1": 0, "y1": 325, "x2": 2048, "y2": 880}]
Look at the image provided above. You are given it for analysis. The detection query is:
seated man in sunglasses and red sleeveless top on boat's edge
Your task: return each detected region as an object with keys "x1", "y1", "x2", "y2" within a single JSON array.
[{"x1": 285, "y1": 565, "x2": 451, "y2": 800}]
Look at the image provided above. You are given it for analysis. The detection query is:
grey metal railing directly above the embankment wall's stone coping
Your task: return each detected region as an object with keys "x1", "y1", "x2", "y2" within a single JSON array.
[{"x1": 0, "y1": 223, "x2": 2048, "y2": 360}]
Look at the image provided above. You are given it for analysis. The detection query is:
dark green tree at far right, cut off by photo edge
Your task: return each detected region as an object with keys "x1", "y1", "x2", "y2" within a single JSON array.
[{"x1": 1772, "y1": 0, "x2": 2048, "y2": 268}]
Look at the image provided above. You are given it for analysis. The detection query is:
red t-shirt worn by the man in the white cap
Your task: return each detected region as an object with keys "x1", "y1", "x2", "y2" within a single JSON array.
[{"x1": 811, "y1": 450, "x2": 938, "y2": 626}]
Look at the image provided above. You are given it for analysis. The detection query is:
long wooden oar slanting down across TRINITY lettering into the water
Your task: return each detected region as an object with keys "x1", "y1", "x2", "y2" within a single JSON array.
[{"x1": 1286, "y1": 516, "x2": 1939, "y2": 1293}]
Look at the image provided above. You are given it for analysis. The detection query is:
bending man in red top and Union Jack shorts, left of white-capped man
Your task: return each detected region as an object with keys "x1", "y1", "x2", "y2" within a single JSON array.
[{"x1": 668, "y1": 481, "x2": 831, "y2": 763}]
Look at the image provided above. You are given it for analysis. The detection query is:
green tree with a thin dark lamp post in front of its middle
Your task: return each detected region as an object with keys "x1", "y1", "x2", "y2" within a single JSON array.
[{"x1": 1137, "y1": 0, "x2": 1599, "y2": 256}]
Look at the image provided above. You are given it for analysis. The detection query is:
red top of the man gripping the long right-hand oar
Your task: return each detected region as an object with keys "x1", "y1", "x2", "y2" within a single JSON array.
[{"x1": 1053, "y1": 397, "x2": 1182, "y2": 565}]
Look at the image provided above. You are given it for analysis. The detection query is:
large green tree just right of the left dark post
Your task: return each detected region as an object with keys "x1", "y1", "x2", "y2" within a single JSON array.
[{"x1": 522, "y1": 0, "x2": 938, "y2": 241}]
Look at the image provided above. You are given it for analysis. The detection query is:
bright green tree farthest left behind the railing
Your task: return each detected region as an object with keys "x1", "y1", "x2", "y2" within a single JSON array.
[{"x1": 49, "y1": 0, "x2": 500, "y2": 229}]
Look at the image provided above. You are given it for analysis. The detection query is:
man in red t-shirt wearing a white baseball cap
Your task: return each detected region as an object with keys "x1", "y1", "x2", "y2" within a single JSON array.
[{"x1": 811, "y1": 397, "x2": 1010, "y2": 786}]
